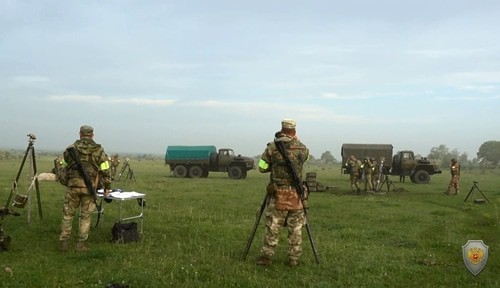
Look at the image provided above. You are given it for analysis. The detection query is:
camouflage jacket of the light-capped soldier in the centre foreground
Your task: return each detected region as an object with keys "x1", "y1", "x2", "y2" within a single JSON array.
[{"x1": 259, "y1": 132, "x2": 309, "y2": 186}]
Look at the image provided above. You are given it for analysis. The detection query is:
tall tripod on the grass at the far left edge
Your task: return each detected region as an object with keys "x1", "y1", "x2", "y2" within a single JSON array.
[{"x1": 2, "y1": 134, "x2": 43, "y2": 222}]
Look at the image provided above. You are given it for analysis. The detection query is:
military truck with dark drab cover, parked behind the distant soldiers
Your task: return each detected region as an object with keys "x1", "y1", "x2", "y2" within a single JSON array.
[{"x1": 341, "y1": 144, "x2": 441, "y2": 184}]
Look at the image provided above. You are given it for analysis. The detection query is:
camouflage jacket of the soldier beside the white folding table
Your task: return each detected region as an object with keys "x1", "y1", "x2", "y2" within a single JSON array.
[{"x1": 63, "y1": 138, "x2": 111, "y2": 189}]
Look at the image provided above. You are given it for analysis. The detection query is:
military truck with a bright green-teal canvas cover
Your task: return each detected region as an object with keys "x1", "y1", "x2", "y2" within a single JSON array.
[{"x1": 165, "y1": 145, "x2": 254, "y2": 179}]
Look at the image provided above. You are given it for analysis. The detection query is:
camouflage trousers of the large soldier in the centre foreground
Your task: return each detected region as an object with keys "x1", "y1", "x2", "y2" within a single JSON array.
[{"x1": 260, "y1": 197, "x2": 305, "y2": 260}]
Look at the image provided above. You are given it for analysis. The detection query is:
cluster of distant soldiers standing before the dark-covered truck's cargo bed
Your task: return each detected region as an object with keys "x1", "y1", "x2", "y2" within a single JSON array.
[{"x1": 345, "y1": 155, "x2": 382, "y2": 194}]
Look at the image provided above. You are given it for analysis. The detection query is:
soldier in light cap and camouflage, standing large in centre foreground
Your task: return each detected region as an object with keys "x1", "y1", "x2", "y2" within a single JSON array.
[{"x1": 257, "y1": 119, "x2": 309, "y2": 266}]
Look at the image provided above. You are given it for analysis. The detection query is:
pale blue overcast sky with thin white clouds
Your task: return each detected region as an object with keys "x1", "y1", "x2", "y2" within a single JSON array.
[{"x1": 0, "y1": 0, "x2": 500, "y2": 159}]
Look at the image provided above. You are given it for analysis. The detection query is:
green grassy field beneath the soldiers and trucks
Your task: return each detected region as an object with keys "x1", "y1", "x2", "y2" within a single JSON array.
[{"x1": 0, "y1": 157, "x2": 500, "y2": 288}]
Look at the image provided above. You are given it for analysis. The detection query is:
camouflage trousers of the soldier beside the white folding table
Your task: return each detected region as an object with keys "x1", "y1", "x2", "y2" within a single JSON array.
[{"x1": 59, "y1": 187, "x2": 96, "y2": 241}]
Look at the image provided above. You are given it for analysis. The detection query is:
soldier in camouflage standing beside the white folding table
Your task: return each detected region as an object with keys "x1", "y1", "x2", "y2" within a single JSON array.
[{"x1": 59, "y1": 125, "x2": 111, "y2": 251}]
